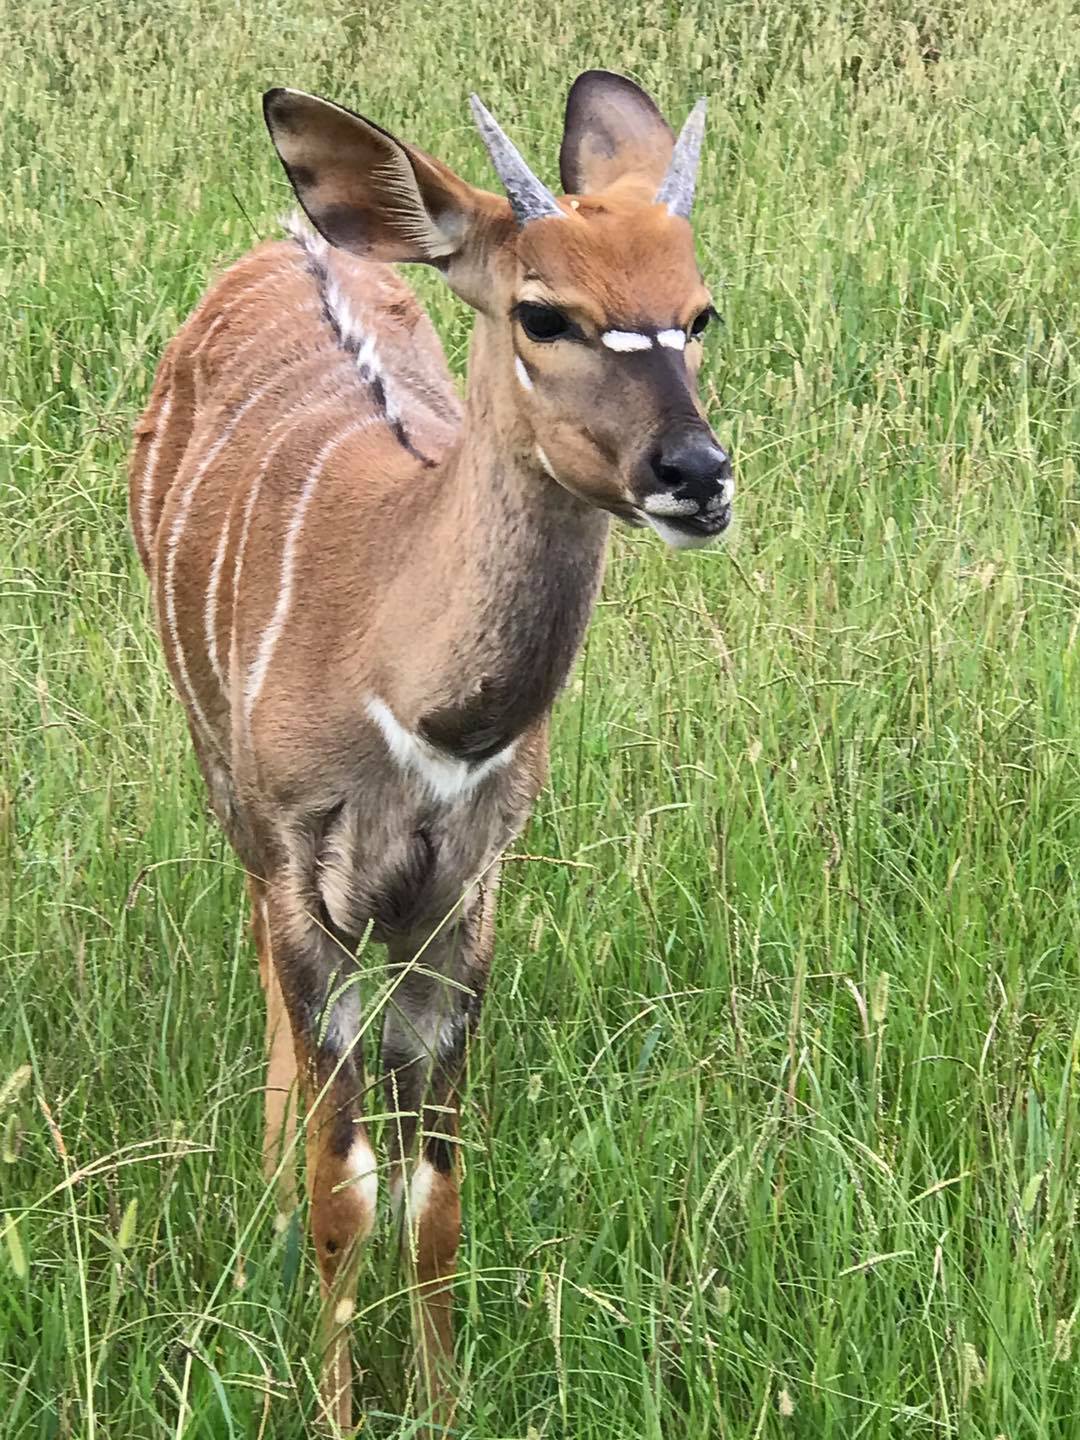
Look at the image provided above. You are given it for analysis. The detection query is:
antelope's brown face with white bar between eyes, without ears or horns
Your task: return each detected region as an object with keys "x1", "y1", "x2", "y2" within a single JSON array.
[{"x1": 507, "y1": 188, "x2": 734, "y2": 549}]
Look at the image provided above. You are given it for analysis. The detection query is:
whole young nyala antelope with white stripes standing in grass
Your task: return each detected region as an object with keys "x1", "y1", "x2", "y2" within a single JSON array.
[{"x1": 130, "y1": 71, "x2": 733, "y2": 1427}]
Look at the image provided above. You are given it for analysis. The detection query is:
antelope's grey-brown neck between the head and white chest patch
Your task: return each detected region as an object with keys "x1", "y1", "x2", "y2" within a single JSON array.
[{"x1": 394, "y1": 318, "x2": 609, "y2": 763}]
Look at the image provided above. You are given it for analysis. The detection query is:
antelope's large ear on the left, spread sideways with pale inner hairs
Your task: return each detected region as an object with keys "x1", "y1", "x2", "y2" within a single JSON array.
[{"x1": 262, "y1": 89, "x2": 513, "y2": 308}]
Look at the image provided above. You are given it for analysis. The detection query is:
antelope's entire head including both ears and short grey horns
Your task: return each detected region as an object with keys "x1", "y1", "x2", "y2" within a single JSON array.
[{"x1": 265, "y1": 61, "x2": 733, "y2": 549}]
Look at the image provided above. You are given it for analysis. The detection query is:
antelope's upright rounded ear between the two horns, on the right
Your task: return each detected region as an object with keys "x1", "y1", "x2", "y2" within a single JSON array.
[{"x1": 559, "y1": 71, "x2": 675, "y2": 194}]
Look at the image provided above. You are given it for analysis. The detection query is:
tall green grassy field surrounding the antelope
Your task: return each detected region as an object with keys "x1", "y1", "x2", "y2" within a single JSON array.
[{"x1": 0, "y1": 0, "x2": 1080, "y2": 1440}]
